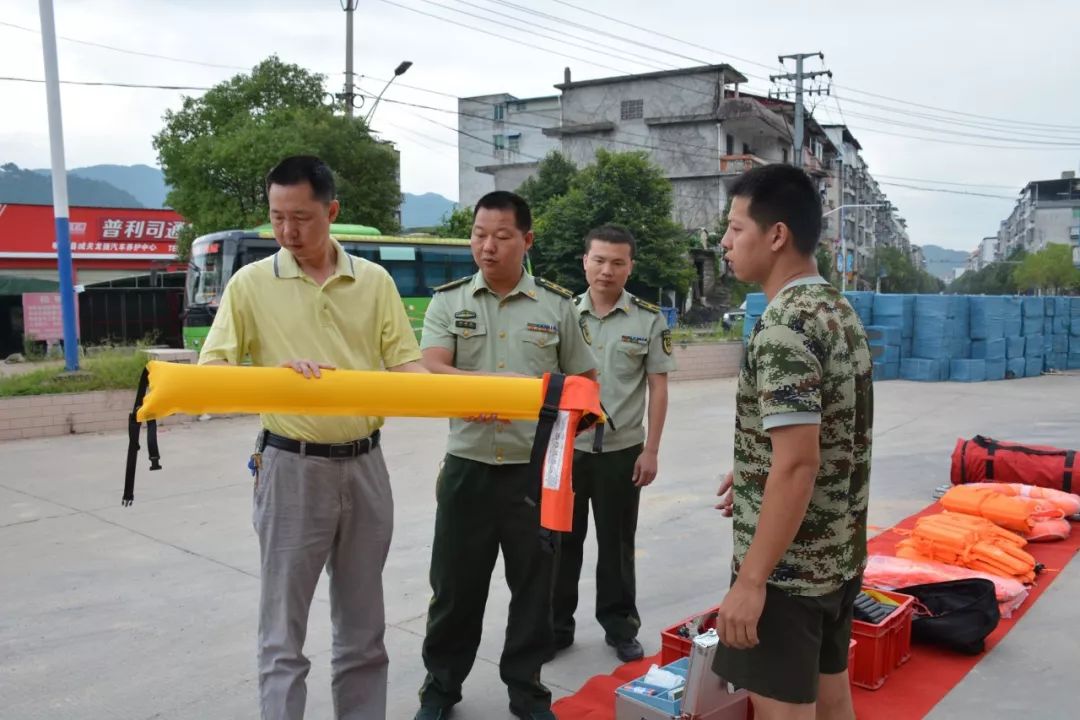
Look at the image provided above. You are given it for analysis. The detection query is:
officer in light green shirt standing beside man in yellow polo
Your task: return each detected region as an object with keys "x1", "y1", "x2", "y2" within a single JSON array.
[{"x1": 416, "y1": 191, "x2": 596, "y2": 720}]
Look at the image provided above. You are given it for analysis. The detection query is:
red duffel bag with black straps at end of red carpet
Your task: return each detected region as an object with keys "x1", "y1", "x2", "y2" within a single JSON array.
[{"x1": 951, "y1": 435, "x2": 1080, "y2": 492}]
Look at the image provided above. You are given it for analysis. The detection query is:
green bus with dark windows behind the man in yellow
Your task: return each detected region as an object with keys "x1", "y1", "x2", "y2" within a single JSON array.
[{"x1": 184, "y1": 225, "x2": 476, "y2": 352}]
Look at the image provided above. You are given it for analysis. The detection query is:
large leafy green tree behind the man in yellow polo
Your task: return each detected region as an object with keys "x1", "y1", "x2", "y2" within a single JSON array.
[{"x1": 153, "y1": 56, "x2": 401, "y2": 257}]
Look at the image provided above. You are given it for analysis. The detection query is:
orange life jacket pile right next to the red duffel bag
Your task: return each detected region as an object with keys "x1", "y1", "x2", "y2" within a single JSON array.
[{"x1": 941, "y1": 483, "x2": 1080, "y2": 541}]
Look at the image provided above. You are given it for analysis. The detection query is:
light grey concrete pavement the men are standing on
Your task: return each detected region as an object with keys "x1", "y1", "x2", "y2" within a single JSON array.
[{"x1": 0, "y1": 375, "x2": 1080, "y2": 720}]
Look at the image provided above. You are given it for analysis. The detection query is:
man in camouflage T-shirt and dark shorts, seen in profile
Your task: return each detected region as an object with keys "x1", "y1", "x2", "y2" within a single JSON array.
[{"x1": 713, "y1": 165, "x2": 874, "y2": 720}]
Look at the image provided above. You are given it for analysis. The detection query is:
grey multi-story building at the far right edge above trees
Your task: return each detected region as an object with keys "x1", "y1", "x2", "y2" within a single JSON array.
[{"x1": 995, "y1": 171, "x2": 1080, "y2": 260}]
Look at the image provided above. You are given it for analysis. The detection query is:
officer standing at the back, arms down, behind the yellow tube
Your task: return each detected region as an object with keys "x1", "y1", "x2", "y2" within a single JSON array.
[{"x1": 554, "y1": 226, "x2": 675, "y2": 662}]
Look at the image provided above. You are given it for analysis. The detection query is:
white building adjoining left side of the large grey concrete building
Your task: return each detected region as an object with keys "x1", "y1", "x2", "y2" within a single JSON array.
[{"x1": 458, "y1": 93, "x2": 561, "y2": 207}]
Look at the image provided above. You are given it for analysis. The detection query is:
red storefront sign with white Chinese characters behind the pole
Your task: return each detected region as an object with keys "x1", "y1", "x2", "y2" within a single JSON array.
[{"x1": 0, "y1": 204, "x2": 185, "y2": 260}]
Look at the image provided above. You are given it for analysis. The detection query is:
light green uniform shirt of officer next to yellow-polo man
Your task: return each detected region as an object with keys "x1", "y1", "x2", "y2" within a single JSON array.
[{"x1": 420, "y1": 272, "x2": 596, "y2": 464}]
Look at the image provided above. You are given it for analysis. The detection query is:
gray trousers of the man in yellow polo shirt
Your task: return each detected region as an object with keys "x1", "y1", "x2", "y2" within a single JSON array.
[{"x1": 253, "y1": 447, "x2": 393, "y2": 720}]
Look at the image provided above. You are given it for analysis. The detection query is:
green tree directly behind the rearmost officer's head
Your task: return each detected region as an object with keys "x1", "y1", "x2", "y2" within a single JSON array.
[{"x1": 534, "y1": 149, "x2": 693, "y2": 300}]
